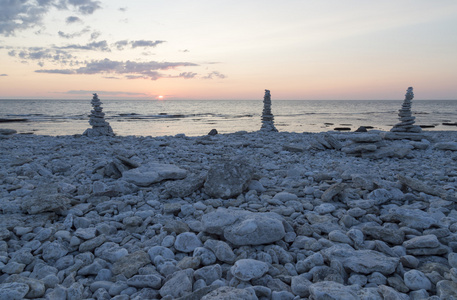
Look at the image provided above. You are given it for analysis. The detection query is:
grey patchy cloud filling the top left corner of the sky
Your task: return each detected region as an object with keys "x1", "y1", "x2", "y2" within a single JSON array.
[{"x1": 0, "y1": 0, "x2": 101, "y2": 36}]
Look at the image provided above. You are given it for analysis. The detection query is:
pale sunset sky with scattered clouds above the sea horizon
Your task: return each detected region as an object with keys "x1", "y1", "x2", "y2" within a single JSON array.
[{"x1": 0, "y1": 0, "x2": 457, "y2": 100}]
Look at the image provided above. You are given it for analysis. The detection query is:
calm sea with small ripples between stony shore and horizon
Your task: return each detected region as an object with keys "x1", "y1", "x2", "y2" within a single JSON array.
[{"x1": 0, "y1": 99, "x2": 457, "y2": 136}]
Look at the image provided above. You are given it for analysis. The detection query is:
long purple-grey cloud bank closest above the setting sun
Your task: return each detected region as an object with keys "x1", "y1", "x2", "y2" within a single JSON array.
[{"x1": 35, "y1": 58, "x2": 198, "y2": 80}]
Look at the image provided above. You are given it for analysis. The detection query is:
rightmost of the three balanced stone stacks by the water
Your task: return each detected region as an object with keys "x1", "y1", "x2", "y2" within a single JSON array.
[{"x1": 385, "y1": 87, "x2": 424, "y2": 141}]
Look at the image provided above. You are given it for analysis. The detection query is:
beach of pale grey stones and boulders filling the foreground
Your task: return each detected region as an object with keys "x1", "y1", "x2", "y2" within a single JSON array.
[{"x1": 0, "y1": 131, "x2": 457, "y2": 299}]
